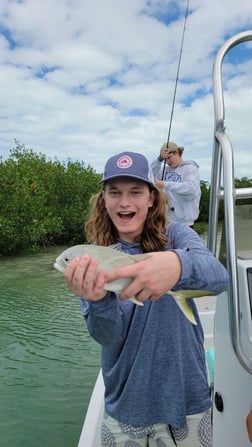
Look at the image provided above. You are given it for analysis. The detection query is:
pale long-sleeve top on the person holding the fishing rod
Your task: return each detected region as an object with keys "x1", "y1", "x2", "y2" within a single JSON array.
[{"x1": 151, "y1": 158, "x2": 201, "y2": 225}]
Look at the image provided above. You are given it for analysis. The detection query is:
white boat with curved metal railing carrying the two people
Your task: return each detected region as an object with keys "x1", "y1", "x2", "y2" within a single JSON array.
[{"x1": 78, "y1": 30, "x2": 252, "y2": 447}]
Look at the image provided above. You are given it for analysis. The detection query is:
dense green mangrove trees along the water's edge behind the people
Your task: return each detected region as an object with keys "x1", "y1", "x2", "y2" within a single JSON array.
[{"x1": 0, "y1": 142, "x2": 252, "y2": 255}]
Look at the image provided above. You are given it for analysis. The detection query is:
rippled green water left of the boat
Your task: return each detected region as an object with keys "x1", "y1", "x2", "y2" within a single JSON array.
[{"x1": 0, "y1": 248, "x2": 100, "y2": 447}]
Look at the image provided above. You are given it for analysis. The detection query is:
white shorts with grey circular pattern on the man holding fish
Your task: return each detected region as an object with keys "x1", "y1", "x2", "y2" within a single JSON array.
[{"x1": 101, "y1": 409, "x2": 212, "y2": 447}]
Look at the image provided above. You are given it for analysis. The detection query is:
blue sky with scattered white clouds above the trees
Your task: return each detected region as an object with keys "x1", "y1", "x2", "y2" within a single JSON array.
[{"x1": 0, "y1": 0, "x2": 252, "y2": 180}]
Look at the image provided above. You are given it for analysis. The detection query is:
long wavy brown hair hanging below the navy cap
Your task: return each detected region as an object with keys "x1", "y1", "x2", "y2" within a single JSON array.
[{"x1": 85, "y1": 184, "x2": 168, "y2": 253}]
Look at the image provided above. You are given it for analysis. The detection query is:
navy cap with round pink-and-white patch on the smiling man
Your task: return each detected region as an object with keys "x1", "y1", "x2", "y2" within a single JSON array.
[{"x1": 100, "y1": 152, "x2": 156, "y2": 188}]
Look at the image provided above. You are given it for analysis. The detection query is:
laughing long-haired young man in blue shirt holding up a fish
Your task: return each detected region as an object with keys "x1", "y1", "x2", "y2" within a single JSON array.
[{"x1": 63, "y1": 152, "x2": 227, "y2": 447}]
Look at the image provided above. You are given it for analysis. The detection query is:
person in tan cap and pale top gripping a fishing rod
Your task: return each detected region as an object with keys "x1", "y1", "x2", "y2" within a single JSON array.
[{"x1": 151, "y1": 142, "x2": 201, "y2": 226}]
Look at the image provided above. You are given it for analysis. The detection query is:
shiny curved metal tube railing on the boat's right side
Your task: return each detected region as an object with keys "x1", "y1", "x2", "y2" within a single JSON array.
[{"x1": 208, "y1": 30, "x2": 252, "y2": 374}]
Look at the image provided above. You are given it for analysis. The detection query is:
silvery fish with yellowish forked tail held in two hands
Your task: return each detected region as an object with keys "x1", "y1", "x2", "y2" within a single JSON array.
[{"x1": 54, "y1": 244, "x2": 215, "y2": 325}]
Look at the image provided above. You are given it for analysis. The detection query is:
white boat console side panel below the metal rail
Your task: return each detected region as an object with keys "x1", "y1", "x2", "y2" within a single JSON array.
[{"x1": 213, "y1": 260, "x2": 252, "y2": 447}]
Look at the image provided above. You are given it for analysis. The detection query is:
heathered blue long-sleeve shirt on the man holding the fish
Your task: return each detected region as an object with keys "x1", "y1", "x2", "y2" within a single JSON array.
[{"x1": 81, "y1": 223, "x2": 227, "y2": 427}]
